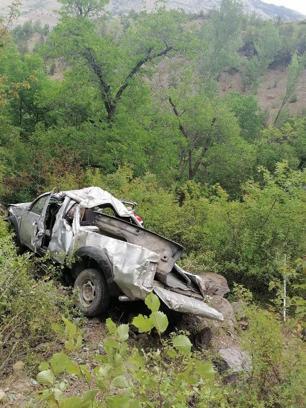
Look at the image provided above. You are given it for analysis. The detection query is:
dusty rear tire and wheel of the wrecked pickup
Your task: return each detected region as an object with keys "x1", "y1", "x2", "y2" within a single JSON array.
[{"x1": 74, "y1": 268, "x2": 110, "y2": 317}]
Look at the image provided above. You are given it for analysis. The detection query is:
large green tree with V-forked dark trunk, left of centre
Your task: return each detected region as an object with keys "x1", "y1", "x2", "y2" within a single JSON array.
[{"x1": 49, "y1": 6, "x2": 182, "y2": 123}]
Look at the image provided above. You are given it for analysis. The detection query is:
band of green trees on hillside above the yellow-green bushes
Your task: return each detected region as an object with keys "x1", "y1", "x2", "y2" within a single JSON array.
[{"x1": 0, "y1": 0, "x2": 305, "y2": 202}]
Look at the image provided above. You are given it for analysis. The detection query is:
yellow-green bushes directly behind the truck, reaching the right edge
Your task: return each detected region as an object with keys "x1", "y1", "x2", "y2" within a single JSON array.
[{"x1": 86, "y1": 162, "x2": 306, "y2": 296}]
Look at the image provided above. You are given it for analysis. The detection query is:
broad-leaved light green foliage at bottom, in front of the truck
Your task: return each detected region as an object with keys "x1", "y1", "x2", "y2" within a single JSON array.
[{"x1": 37, "y1": 294, "x2": 221, "y2": 407}]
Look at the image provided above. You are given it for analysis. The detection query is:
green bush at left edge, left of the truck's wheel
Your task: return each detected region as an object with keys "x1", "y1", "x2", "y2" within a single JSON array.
[{"x1": 0, "y1": 220, "x2": 68, "y2": 374}]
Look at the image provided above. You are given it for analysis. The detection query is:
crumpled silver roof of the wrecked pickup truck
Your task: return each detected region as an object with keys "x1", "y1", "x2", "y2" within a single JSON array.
[{"x1": 64, "y1": 187, "x2": 131, "y2": 217}]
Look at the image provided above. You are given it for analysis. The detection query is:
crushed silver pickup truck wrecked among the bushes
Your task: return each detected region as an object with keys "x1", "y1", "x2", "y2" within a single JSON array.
[{"x1": 8, "y1": 187, "x2": 223, "y2": 320}]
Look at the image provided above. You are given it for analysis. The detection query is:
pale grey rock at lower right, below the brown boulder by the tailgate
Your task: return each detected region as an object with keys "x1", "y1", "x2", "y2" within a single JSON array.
[{"x1": 217, "y1": 346, "x2": 251, "y2": 372}]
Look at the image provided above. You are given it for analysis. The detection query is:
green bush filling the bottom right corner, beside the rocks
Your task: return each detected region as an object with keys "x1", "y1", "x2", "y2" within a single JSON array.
[{"x1": 230, "y1": 305, "x2": 306, "y2": 408}]
